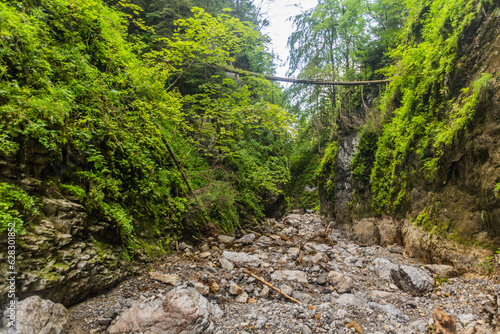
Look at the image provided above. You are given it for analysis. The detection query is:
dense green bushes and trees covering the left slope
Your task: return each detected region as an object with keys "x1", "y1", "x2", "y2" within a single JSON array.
[{"x1": 0, "y1": 0, "x2": 290, "y2": 248}]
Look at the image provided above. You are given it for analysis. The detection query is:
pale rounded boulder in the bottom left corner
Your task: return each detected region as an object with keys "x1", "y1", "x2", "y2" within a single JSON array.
[{"x1": 12, "y1": 296, "x2": 68, "y2": 334}]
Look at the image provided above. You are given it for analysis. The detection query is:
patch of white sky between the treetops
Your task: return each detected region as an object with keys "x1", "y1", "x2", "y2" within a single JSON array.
[{"x1": 262, "y1": 0, "x2": 317, "y2": 77}]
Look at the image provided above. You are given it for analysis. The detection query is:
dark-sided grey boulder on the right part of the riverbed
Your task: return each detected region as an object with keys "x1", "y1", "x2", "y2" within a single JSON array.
[{"x1": 391, "y1": 265, "x2": 434, "y2": 296}]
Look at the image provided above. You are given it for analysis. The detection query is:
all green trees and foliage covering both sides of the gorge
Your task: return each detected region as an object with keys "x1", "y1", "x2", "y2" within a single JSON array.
[{"x1": 0, "y1": 0, "x2": 500, "y2": 253}]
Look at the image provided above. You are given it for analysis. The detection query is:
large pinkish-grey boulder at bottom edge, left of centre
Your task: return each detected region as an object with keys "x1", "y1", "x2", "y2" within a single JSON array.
[{"x1": 107, "y1": 286, "x2": 223, "y2": 334}]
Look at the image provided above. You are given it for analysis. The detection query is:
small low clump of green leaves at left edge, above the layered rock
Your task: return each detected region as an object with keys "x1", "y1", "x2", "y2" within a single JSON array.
[{"x1": 0, "y1": 182, "x2": 40, "y2": 233}]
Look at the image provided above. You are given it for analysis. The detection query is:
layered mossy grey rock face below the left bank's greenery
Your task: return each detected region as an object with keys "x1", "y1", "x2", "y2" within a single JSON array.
[{"x1": 0, "y1": 198, "x2": 144, "y2": 306}]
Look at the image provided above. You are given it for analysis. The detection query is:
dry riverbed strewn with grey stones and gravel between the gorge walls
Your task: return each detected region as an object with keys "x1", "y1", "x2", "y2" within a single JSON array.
[{"x1": 3, "y1": 214, "x2": 500, "y2": 334}]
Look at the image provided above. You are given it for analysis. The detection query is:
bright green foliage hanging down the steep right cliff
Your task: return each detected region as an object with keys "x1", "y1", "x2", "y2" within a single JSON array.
[{"x1": 371, "y1": 0, "x2": 490, "y2": 213}]
